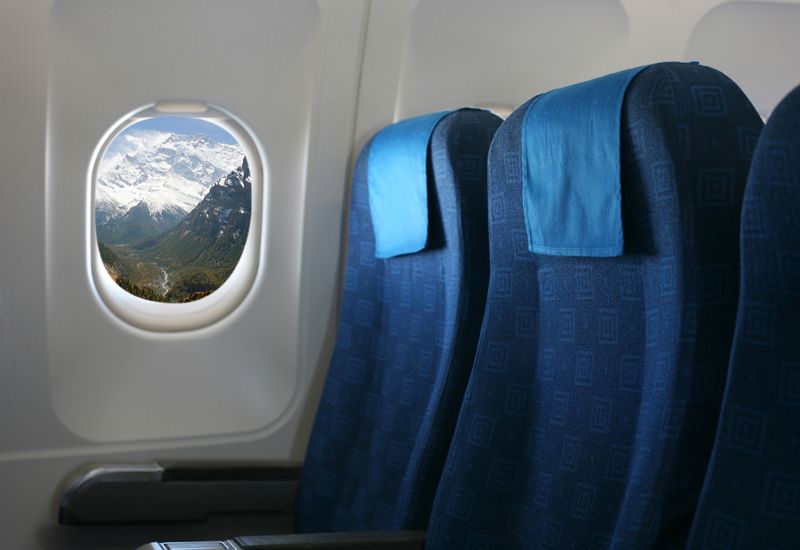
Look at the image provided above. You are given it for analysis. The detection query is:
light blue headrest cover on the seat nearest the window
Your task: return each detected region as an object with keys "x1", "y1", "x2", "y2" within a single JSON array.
[{"x1": 367, "y1": 111, "x2": 453, "y2": 258}]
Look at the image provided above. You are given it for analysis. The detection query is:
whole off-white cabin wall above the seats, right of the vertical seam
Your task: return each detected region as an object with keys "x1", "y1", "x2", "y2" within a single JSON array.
[{"x1": 356, "y1": 0, "x2": 800, "y2": 145}]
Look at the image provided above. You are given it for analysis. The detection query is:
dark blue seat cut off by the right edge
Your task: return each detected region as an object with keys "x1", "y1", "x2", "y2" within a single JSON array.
[{"x1": 689, "y1": 87, "x2": 800, "y2": 549}]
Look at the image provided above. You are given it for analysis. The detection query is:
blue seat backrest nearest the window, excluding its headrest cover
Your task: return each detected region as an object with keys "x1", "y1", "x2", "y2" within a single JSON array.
[{"x1": 296, "y1": 110, "x2": 501, "y2": 532}]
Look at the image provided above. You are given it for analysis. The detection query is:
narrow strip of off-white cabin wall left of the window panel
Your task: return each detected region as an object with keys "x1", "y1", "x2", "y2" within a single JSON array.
[{"x1": 0, "y1": 0, "x2": 53, "y2": 458}]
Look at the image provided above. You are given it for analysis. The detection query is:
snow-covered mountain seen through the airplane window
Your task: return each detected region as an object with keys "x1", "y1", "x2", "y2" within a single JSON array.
[{"x1": 95, "y1": 131, "x2": 244, "y2": 241}]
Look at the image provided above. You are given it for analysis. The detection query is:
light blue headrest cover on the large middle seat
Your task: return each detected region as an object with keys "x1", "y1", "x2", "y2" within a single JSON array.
[{"x1": 522, "y1": 65, "x2": 649, "y2": 257}]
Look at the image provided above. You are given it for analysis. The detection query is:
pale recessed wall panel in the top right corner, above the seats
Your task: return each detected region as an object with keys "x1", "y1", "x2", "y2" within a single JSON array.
[{"x1": 686, "y1": 1, "x2": 800, "y2": 117}]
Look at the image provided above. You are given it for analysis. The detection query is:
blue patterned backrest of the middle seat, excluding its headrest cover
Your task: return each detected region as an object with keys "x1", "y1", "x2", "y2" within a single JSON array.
[{"x1": 426, "y1": 63, "x2": 762, "y2": 550}]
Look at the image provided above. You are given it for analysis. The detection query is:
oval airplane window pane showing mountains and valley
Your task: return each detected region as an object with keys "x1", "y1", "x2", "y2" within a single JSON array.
[{"x1": 94, "y1": 115, "x2": 252, "y2": 303}]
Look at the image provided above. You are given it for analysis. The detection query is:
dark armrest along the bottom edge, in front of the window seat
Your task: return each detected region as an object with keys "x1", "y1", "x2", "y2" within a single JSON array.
[{"x1": 137, "y1": 530, "x2": 425, "y2": 550}]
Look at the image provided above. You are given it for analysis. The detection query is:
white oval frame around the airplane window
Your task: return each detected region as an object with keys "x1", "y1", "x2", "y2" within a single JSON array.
[{"x1": 87, "y1": 101, "x2": 268, "y2": 333}]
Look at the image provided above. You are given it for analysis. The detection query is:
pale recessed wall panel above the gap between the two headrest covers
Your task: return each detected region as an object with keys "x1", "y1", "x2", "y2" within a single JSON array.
[{"x1": 396, "y1": 0, "x2": 628, "y2": 118}]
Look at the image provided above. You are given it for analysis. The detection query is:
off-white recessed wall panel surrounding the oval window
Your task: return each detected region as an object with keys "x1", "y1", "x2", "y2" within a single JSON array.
[{"x1": 42, "y1": 0, "x2": 368, "y2": 448}]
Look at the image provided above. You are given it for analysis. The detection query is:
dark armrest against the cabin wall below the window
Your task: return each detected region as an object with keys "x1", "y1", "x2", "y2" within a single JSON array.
[{"x1": 58, "y1": 463, "x2": 300, "y2": 525}]
